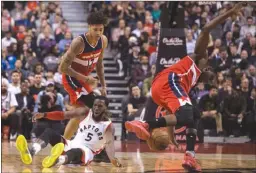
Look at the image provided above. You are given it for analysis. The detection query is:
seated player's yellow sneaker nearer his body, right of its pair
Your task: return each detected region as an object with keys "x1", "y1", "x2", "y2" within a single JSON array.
[{"x1": 42, "y1": 143, "x2": 64, "y2": 168}]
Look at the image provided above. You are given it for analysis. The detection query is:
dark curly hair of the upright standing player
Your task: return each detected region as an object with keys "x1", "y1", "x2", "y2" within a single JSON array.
[{"x1": 87, "y1": 11, "x2": 108, "y2": 26}]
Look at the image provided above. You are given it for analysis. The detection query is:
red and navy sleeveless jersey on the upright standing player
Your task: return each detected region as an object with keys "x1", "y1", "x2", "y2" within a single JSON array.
[{"x1": 71, "y1": 34, "x2": 103, "y2": 75}]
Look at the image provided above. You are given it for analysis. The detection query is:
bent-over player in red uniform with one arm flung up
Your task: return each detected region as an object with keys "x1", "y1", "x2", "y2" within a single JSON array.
[{"x1": 125, "y1": 2, "x2": 243, "y2": 171}]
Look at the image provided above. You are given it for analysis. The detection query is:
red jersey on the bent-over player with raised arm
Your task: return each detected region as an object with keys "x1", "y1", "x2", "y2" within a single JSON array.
[{"x1": 153, "y1": 56, "x2": 201, "y2": 93}]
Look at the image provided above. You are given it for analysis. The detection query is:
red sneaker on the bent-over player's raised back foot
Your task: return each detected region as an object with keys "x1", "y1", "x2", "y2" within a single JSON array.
[{"x1": 125, "y1": 120, "x2": 150, "y2": 140}]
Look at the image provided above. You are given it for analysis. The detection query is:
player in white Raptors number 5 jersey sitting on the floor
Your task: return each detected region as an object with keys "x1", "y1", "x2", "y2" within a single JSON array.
[{"x1": 16, "y1": 96, "x2": 121, "y2": 168}]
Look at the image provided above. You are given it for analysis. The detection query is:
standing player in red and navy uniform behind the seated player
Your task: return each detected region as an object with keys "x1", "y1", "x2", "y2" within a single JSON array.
[{"x1": 59, "y1": 12, "x2": 108, "y2": 139}]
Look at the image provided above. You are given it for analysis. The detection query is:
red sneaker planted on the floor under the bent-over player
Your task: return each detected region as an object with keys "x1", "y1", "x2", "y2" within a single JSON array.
[{"x1": 182, "y1": 153, "x2": 202, "y2": 172}]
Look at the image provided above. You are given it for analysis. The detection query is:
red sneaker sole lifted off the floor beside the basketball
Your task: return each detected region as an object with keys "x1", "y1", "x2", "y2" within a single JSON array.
[{"x1": 125, "y1": 121, "x2": 150, "y2": 140}]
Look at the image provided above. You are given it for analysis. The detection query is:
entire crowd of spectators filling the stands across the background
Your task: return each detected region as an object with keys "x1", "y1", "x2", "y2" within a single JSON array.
[{"x1": 1, "y1": 1, "x2": 256, "y2": 141}]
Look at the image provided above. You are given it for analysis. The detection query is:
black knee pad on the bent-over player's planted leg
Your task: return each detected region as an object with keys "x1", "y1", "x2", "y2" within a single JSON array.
[{"x1": 175, "y1": 104, "x2": 194, "y2": 128}]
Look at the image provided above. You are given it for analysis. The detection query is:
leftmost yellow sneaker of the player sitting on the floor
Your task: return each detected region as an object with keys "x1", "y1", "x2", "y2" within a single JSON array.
[{"x1": 16, "y1": 135, "x2": 32, "y2": 165}]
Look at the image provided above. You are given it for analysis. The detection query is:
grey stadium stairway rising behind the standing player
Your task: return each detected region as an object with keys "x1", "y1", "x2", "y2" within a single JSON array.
[{"x1": 60, "y1": 1, "x2": 129, "y2": 138}]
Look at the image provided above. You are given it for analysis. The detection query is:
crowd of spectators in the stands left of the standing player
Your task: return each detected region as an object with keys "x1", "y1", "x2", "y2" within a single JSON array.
[{"x1": 1, "y1": 1, "x2": 72, "y2": 140}]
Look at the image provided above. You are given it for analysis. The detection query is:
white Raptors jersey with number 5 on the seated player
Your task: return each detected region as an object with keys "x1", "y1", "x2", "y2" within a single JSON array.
[{"x1": 72, "y1": 109, "x2": 112, "y2": 153}]
